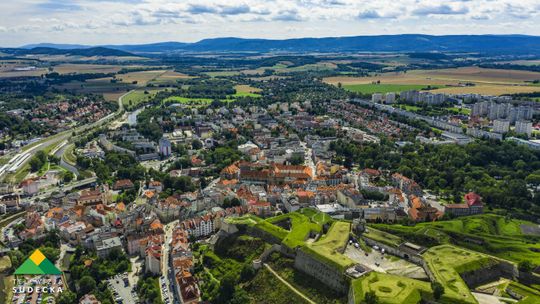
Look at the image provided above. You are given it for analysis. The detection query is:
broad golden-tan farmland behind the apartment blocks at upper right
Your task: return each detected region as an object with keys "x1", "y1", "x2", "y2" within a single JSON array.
[{"x1": 324, "y1": 67, "x2": 540, "y2": 95}]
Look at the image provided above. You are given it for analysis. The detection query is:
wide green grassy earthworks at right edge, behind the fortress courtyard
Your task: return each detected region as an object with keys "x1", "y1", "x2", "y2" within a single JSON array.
[{"x1": 373, "y1": 214, "x2": 540, "y2": 265}]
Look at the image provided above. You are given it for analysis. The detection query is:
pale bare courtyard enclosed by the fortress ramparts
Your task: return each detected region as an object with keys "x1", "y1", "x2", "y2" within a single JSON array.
[{"x1": 345, "y1": 245, "x2": 427, "y2": 279}]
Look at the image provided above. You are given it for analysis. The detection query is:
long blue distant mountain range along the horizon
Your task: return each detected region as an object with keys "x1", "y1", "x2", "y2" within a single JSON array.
[{"x1": 8, "y1": 34, "x2": 540, "y2": 56}]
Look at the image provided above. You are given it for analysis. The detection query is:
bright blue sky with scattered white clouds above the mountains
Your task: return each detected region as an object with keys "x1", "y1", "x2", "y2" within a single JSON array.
[{"x1": 0, "y1": 0, "x2": 540, "y2": 47}]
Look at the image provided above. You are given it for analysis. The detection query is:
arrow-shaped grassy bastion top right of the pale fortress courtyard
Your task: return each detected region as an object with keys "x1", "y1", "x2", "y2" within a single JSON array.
[{"x1": 423, "y1": 245, "x2": 497, "y2": 303}]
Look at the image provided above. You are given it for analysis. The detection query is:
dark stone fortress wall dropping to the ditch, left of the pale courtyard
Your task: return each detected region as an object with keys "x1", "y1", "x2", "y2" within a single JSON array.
[{"x1": 294, "y1": 249, "x2": 349, "y2": 294}]
